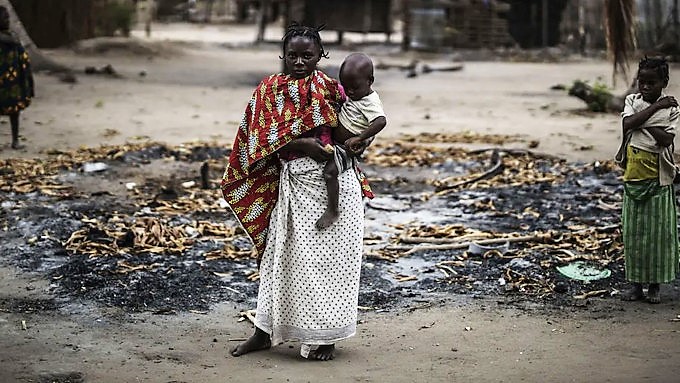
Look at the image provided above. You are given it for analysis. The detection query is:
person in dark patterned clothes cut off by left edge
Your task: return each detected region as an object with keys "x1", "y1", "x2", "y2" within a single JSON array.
[{"x1": 0, "y1": 7, "x2": 33, "y2": 149}]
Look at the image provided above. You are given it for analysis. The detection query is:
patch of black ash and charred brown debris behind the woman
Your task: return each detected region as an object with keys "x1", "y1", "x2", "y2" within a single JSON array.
[{"x1": 0, "y1": 145, "x2": 678, "y2": 314}]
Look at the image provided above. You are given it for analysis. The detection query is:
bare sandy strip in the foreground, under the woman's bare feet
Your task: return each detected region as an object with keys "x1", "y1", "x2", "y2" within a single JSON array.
[{"x1": 0, "y1": 268, "x2": 680, "y2": 383}]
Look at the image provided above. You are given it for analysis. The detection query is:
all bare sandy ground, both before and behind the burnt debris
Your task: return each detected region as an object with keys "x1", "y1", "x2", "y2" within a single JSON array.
[{"x1": 0, "y1": 24, "x2": 680, "y2": 382}]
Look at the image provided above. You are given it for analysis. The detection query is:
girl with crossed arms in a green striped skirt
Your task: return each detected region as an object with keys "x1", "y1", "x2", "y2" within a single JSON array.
[{"x1": 616, "y1": 57, "x2": 680, "y2": 303}]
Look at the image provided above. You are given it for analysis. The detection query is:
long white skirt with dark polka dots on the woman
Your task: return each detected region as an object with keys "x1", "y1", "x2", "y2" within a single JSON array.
[{"x1": 255, "y1": 158, "x2": 364, "y2": 345}]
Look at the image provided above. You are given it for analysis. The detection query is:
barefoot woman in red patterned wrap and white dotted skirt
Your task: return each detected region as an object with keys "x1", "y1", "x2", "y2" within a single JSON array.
[{"x1": 222, "y1": 24, "x2": 372, "y2": 360}]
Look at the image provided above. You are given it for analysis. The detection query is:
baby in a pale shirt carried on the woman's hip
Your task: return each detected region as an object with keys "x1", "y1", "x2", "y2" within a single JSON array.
[{"x1": 316, "y1": 53, "x2": 387, "y2": 229}]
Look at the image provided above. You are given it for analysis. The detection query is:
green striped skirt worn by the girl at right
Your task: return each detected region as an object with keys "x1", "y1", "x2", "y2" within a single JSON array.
[{"x1": 621, "y1": 180, "x2": 680, "y2": 283}]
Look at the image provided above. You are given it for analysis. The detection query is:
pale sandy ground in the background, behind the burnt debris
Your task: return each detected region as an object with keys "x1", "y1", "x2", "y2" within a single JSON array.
[{"x1": 0, "y1": 22, "x2": 648, "y2": 161}]
